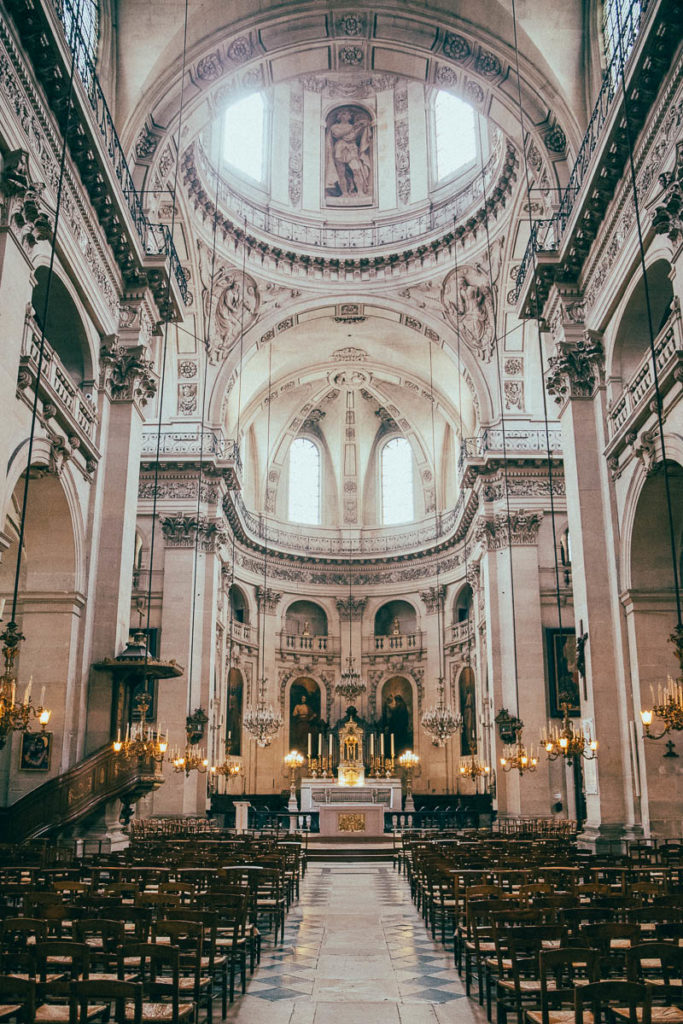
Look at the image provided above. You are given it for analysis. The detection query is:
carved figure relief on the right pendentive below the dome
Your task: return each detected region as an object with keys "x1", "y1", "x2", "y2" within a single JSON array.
[{"x1": 441, "y1": 238, "x2": 504, "y2": 362}]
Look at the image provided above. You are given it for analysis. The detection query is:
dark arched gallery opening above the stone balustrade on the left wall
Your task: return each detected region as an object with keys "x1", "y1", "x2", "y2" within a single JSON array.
[{"x1": 31, "y1": 265, "x2": 94, "y2": 384}]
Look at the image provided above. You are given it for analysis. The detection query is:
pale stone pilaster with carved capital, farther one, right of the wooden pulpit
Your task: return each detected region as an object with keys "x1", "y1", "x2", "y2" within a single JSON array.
[{"x1": 154, "y1": 512, "x2": 226, "y2": 815}]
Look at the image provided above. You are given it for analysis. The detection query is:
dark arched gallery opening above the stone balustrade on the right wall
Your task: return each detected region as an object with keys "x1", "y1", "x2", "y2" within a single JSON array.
[{"x1": 607, "y1": 257, "x2": 674, "y2": 398}]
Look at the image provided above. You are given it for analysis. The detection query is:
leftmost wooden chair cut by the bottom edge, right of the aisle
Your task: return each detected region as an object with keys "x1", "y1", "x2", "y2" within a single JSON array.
[{"x1": 524, "y1": 946, "x2": 600, "y2": 1024}]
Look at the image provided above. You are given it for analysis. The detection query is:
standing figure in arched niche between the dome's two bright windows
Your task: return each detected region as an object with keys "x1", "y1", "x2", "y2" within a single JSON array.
[{"x1": 325, "y1": 104, "x2": 375, "y2": 207}]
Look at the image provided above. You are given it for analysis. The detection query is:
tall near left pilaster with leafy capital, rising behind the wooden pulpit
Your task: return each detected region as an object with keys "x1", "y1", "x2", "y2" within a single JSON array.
[{"x1": 81, "y1": 293, "x2": 157, "y2": 754}]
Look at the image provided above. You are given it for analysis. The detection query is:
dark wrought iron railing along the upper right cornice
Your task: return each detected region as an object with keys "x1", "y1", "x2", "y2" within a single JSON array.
[{"x1": 515, "y1": 0, "x2": 651, "y2": 302}]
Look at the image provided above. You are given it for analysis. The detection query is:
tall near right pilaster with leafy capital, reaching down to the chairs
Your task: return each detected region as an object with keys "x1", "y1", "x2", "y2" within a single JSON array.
[{"x1": 545, "y1": 286, "x2": 640, "y2": 845}]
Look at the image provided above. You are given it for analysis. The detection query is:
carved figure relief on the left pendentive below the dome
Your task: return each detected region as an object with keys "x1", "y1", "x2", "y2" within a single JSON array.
[{"x1": 198, "y1": 241, "x2": 259, "y2": 362}]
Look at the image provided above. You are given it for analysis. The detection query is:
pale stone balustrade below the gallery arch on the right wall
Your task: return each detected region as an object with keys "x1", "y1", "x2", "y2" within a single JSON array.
[{"x1": 607, "y1": 306, "x2": 683, "y2": 449}]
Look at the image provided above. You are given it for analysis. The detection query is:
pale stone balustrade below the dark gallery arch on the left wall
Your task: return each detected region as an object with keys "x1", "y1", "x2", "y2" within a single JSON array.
[{"x1": 18, "y1": 316, "x2": 99, "y2": 461}]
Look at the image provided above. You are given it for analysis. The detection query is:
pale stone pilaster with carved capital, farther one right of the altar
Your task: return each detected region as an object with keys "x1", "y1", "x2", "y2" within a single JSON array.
[{"x1": 476, "y1": 509, "x2": 550, "y2": 816}]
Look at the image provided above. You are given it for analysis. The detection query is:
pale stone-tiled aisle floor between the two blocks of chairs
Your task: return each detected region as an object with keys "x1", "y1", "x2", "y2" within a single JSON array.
[{"x1": 227, "y1": 861, "x2": 485, "y2": 1024}]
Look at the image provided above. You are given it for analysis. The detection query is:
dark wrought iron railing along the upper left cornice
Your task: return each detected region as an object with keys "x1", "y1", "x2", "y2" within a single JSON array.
[{"x1": 52, "y1": 0, "x2": 189, "y2": 305}]
